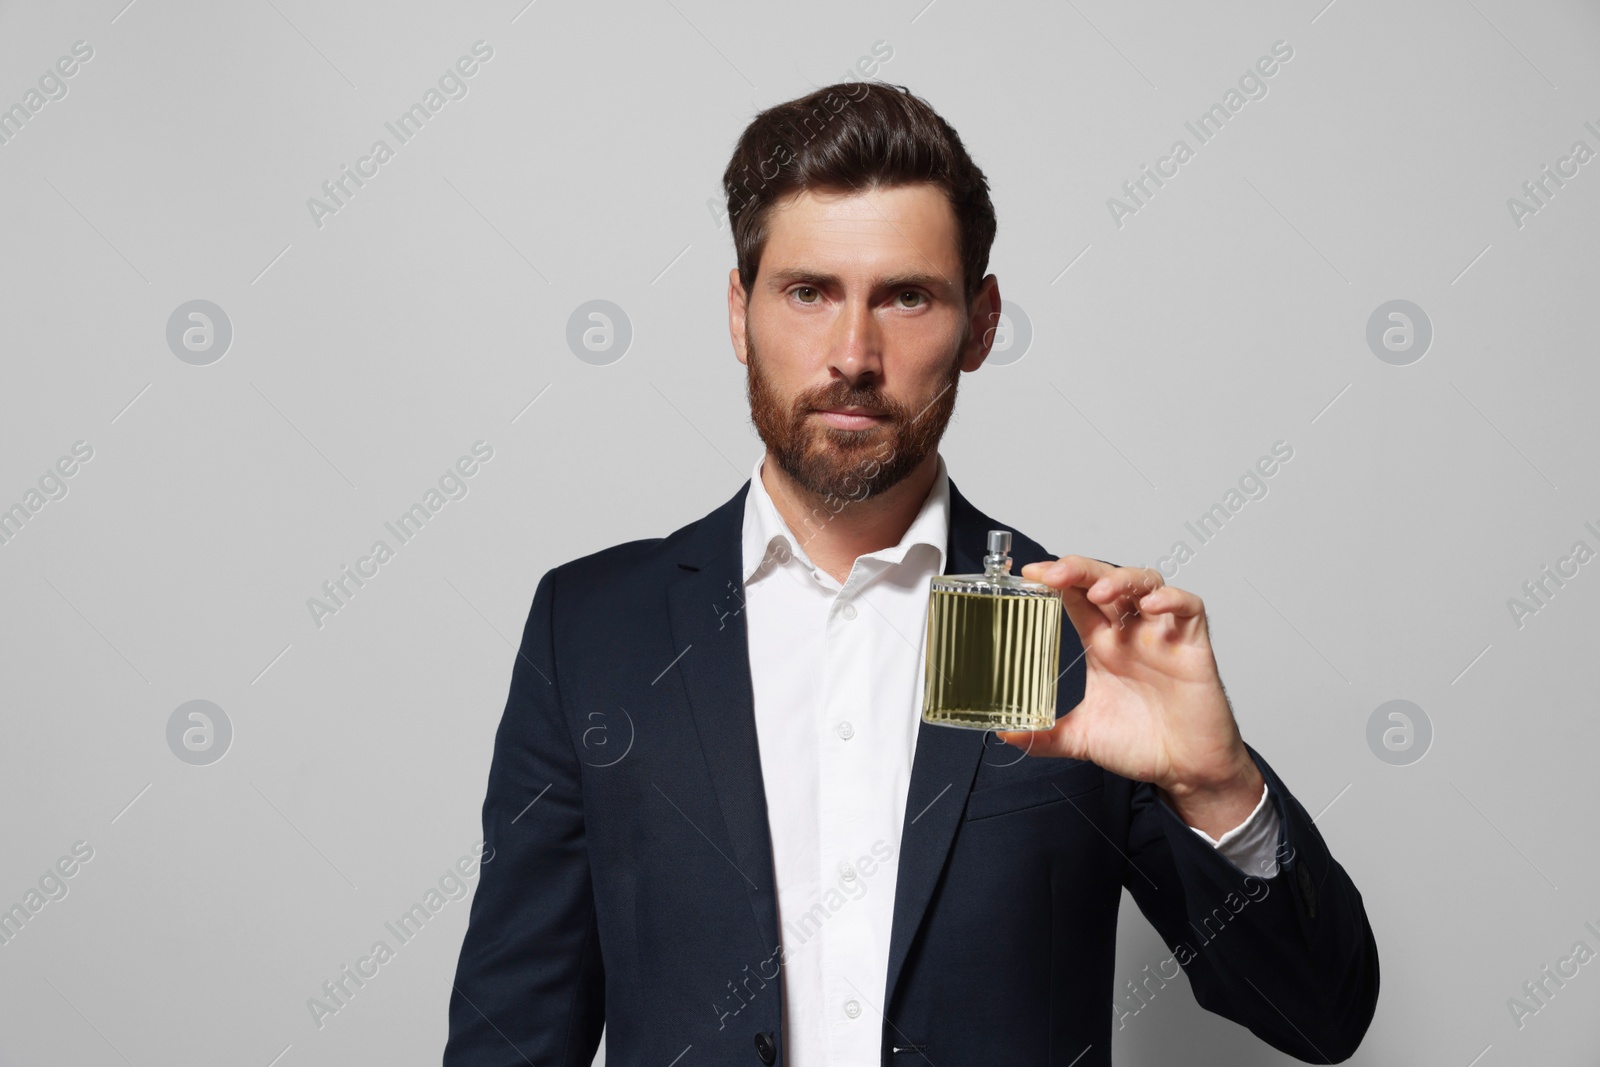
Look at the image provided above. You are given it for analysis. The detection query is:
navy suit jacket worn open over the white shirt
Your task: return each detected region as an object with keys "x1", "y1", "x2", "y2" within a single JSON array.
[{"x1": 443, "y1": 480, "x2": 1378, "y2": 1067}]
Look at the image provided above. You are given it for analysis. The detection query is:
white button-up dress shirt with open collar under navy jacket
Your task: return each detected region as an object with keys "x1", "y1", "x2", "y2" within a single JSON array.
[{"x1": 742, "y1": 454, "x2": 1278, "y2": 1067}]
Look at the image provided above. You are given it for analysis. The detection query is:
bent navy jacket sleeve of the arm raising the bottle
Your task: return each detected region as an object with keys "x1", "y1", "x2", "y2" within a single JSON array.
[{"x1": 1123, "y1": 744, "x2": 1378, "y2": 1064}]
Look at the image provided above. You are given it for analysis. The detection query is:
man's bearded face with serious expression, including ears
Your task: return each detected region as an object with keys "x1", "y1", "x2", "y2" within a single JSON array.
[{"x1": 728, "y1": 184, "x2": 998, "y2": 499}]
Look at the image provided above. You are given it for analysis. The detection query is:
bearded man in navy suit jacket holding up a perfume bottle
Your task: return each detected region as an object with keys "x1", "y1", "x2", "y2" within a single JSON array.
[{"x1": 445, "y1": 83, "x2": 1378, "y2": 1067}]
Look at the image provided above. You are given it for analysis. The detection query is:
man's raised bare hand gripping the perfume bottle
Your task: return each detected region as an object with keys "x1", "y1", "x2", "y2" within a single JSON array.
[{"x1": 995, "y1": 555, "x2": 1262, "y2": 838}]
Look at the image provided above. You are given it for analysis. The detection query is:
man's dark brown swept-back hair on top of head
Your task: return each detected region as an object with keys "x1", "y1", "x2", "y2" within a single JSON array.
[{"x1": 722, "y1": 82, "x2": 995, "y2": 301}]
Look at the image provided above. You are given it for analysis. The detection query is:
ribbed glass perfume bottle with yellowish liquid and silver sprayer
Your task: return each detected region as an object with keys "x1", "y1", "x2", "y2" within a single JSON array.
[{"x1": 922, "y1": 530, "x2": 1062, "y2": 729}]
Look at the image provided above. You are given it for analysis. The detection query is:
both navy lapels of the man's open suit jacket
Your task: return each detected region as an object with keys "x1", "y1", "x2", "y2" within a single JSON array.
[{"x1": 667, "y1": 480, "x2": 990, "y2": 1011}]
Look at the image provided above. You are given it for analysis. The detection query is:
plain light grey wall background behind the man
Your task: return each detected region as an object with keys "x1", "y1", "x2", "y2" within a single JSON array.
[{"x1": 0, "y1": 0, "x2": 1600, "y2": 1067}]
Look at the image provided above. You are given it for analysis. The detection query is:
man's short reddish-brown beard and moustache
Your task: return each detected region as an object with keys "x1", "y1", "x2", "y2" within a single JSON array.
[{"x1": 744, "y1": 322, "x2": 966, "y2": 501}]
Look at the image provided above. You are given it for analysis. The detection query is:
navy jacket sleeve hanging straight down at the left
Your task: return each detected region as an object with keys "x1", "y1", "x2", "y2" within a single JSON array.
[{"x1": 443, "y1": 571, "x2": 605, "y2": 1067}]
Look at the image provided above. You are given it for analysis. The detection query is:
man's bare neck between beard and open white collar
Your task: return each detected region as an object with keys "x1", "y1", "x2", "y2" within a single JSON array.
[{"x1": 762, "y1": 451, "x2": 939, "y2": 584}]
